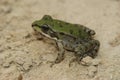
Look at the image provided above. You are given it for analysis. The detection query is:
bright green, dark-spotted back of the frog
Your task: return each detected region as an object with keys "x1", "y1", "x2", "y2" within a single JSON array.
[{"x1": 41, "y1": 15, "x2": 94, "y2": 38}]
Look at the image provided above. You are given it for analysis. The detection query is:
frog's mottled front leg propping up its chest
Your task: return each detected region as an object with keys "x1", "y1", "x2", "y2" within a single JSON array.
[{"x1": 51, "y1": 40, "x2": 65, "y2": 67}]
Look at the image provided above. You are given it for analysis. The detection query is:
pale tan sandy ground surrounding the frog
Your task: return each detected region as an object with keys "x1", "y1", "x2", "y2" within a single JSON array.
[{"x1": 0, "y1": 0, "x2": 120, "y2": 80}]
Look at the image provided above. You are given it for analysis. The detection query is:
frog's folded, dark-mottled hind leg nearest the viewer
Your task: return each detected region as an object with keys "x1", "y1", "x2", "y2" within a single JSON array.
[{"x1": 75, "y1": 40, "x2": 100, "y2": 63}]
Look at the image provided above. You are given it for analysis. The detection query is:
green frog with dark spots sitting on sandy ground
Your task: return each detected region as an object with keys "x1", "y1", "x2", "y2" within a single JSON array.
[{"x1": 32, "y1": 15, "x2": 100, "y2": 67}]
